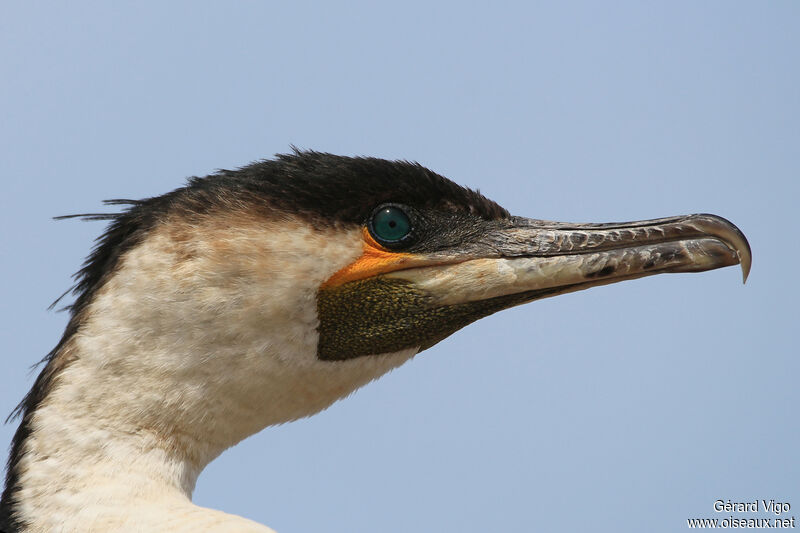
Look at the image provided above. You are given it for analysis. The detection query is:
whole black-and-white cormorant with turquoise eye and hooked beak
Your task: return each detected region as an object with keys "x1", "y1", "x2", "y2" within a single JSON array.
[{"x1": 0, "y1": 151, "x2": 750, "y2": 533}]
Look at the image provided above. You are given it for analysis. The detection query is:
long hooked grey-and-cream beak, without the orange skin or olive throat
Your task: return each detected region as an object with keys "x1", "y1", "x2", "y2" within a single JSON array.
[{"x1": 385, "y1": 214, "x2": 751, "y2": 307}]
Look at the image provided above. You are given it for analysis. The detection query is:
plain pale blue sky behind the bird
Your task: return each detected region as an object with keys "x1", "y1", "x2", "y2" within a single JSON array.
[{"x1": 0, "y1": 1, "x2": 800, "y2": 533}]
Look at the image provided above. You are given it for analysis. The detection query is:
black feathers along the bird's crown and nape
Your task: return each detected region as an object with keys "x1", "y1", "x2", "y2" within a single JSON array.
[{"x1": 0, "y1": 150, "x2": 509, "y2": 530}]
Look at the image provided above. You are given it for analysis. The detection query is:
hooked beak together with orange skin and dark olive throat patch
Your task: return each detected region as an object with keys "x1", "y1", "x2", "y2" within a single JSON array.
[{"x1": 317, "y1": 211, "x2": 750, "y2": 360}]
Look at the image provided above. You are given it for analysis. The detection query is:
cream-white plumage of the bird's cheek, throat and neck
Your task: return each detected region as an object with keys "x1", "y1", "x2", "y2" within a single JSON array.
[{"x1": 6, "y1": 218, "x2": 417, "y2": 533}]
